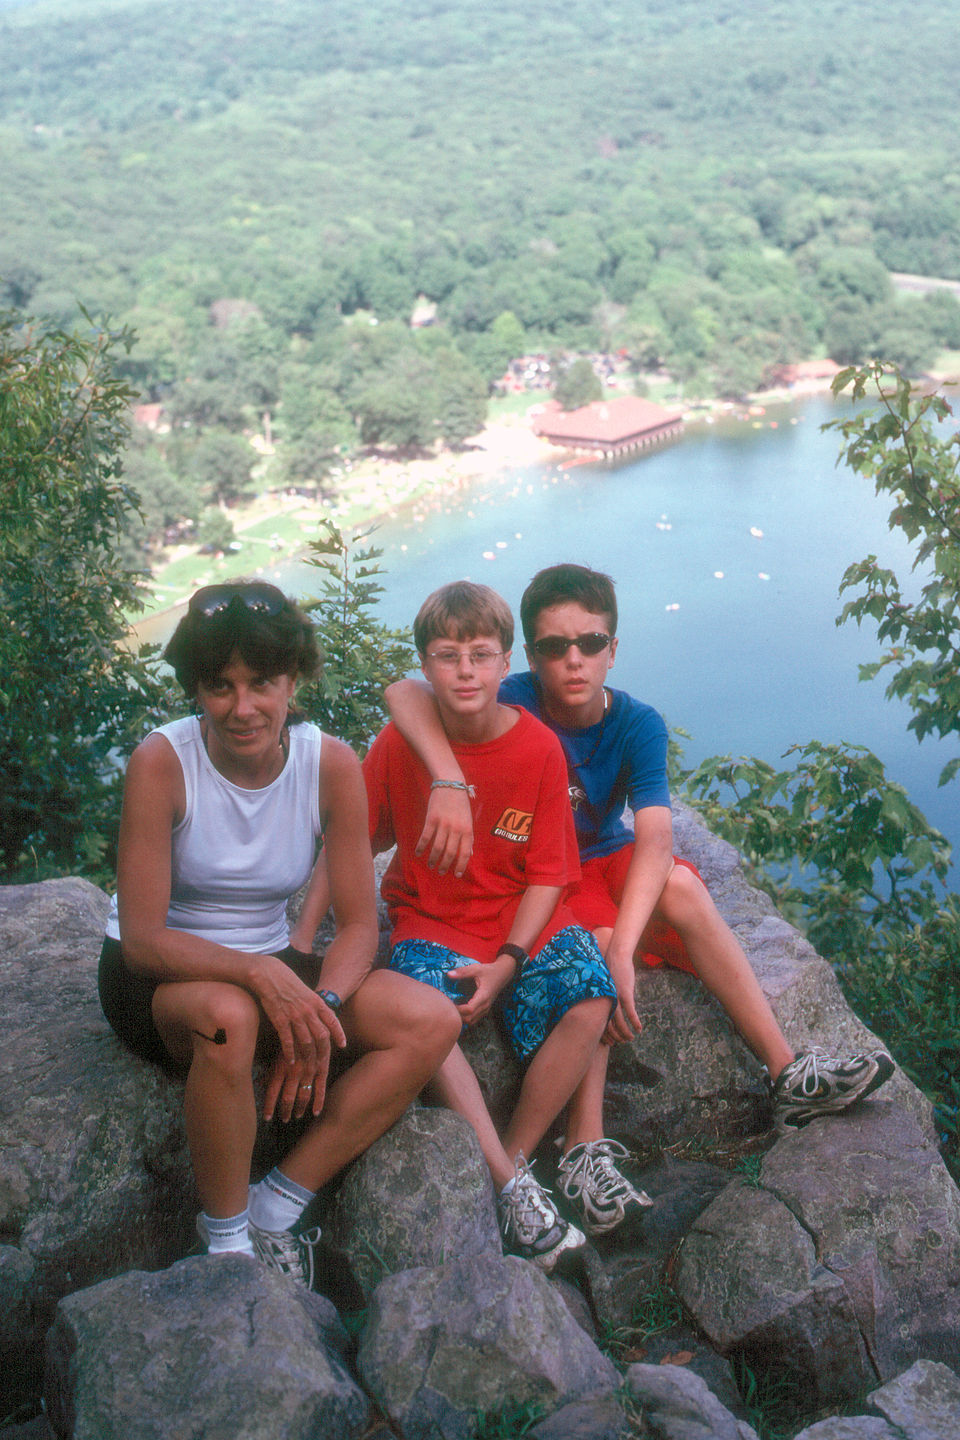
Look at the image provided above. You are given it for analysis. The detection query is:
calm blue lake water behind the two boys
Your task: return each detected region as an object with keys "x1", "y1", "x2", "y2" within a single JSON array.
[{"x1": 144, "y1": 399, "x2": 960, "y2": 851}]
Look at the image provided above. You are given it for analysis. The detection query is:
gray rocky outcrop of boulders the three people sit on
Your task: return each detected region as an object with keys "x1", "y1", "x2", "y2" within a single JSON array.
[{"x1": 0, "y1": 812, "x2": 960, "y2": 1440}]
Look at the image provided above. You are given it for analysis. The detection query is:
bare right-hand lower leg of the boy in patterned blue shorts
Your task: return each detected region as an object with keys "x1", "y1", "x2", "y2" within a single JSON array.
[{"x1": 504, "y1": 996, "x2": 610, "y2": 1159}]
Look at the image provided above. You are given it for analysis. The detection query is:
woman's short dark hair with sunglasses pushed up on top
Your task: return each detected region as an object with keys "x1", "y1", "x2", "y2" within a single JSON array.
[{"x1": 164, "y1": 580, "x2": 322, "y2": 700}]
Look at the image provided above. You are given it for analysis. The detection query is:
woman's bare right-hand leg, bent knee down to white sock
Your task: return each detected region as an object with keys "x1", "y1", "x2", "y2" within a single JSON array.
[{"x1": 281, "y1": 971, "x2": 461, "y2": 1189}]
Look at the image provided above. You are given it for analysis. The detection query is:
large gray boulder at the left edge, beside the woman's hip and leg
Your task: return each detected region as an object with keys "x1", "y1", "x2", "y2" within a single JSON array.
[{"x1": 0, "y1": 880, "x2": 196, "y2": 1411}]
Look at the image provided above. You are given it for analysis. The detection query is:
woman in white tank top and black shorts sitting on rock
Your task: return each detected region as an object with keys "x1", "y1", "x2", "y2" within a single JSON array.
[{"x1": 99, "y1": 582, "x2": 459, "y2": 1284}]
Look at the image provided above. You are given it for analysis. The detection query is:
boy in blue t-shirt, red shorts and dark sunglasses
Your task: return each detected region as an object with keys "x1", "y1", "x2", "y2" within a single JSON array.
[{"x1": 387, "y1": 564, "x2": 894, "y2": 1236}]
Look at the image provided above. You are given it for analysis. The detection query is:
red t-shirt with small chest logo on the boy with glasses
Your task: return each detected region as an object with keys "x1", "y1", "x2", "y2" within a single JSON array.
[{"x1": 363, "y1": 707, "x2": 580, "y2": 963}]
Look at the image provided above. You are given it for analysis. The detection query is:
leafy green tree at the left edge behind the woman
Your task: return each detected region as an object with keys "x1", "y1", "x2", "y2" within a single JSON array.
[{"x1": 0, "y1": 312, "x2": 163, "y2": 874}]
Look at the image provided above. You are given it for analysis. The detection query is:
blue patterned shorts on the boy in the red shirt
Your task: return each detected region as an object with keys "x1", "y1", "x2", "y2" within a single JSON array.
[{"x1": 389, "y1": 924, "x2": 616, "y2": 1064}]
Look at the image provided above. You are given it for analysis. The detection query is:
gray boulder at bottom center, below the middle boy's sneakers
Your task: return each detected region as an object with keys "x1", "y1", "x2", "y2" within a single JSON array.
[{"x1": 358, "y1": 1254, "x2": 620, "y2": 1440}]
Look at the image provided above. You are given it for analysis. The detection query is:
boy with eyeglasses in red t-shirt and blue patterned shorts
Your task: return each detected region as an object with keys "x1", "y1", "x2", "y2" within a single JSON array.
[{"x1": 364, "y1": 580, "x2": 616, "y2": 1270}]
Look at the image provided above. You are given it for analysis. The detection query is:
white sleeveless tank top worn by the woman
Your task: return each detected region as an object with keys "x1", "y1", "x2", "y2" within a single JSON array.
[{"x1": 107, "y1": 716, "x2": 322, "y2": 955}]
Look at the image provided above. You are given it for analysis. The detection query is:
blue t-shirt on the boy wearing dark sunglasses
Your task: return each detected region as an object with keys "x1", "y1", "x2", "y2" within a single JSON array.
[{"x1": 499, "y1": 671, "x2": 671, "y2": 860}]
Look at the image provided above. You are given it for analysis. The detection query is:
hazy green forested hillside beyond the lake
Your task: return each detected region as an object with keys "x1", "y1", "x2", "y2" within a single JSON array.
[{"x1": 0, "y1": 0, "x2": 960, "y2": 544}]
